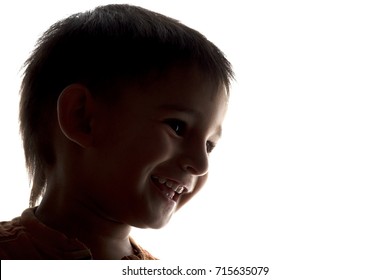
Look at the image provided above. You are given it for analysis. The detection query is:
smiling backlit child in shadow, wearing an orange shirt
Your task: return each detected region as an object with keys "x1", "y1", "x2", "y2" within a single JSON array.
[{"x1": 0, "y1": 5, "x2": 233, "y2": 259}]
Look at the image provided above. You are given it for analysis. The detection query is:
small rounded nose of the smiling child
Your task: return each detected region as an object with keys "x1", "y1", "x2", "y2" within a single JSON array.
[{"x1": 180, "y1": 144, "x2": 209, "y2": 176}]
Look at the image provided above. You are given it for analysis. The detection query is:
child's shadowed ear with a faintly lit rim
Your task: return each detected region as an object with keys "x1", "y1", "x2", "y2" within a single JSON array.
[{"x1": 57, "y1": 84, "x2": 94, "y2": 148}]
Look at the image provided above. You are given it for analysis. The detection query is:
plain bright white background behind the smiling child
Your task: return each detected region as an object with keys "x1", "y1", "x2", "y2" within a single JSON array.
[{"x1": 0, "y1": 0, "x2": 390, "y2": 279}]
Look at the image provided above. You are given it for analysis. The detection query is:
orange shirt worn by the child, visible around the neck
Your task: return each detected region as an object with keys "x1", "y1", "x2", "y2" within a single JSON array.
[{"x1": 0, "y1": 208, "x2": 156, "y2": 260}]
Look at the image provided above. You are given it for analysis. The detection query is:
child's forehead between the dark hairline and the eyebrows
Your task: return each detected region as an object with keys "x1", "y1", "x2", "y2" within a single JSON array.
[{"x1": 106, "y1": 63, "x2": 228, "y2": 135}]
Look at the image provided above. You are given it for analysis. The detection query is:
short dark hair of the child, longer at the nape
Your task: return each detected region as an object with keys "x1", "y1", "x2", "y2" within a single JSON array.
[{"x1": 19, "y1": 5, "x2": 233, "y2": 206}]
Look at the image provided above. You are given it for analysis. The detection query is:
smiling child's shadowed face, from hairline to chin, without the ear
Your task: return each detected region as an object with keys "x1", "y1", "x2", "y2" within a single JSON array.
[{"x1": 84, "y1": 64, "x2": 228, "y2": 228}]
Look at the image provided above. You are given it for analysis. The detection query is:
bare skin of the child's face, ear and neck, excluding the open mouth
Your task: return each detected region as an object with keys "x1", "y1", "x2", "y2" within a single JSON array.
[{"x1": 36, "y1": 66, "x2": 228, "y2": 259}]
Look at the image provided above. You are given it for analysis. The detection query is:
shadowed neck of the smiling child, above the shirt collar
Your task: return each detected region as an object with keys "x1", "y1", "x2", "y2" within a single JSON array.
[{"x1": 36, "y1": 188, "x2": 133, "y2": 259}]
